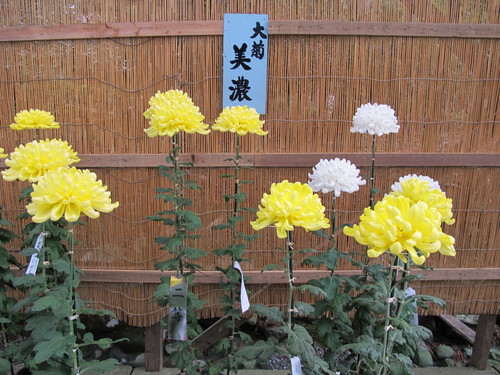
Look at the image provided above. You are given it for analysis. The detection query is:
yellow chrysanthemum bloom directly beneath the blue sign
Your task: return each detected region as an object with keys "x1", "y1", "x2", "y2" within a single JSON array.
[{"x1": 212, "y1": 105, "x2": 267, "y2": 135}]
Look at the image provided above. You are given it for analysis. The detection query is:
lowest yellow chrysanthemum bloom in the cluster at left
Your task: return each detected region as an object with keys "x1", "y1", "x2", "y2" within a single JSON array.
[{"x1": 26, "y1": 167, "x2": 119, "y2": 223}]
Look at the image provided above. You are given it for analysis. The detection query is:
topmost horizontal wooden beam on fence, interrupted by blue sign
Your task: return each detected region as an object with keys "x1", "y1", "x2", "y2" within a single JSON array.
[{"x1": 0, "y1": 20, "x2": 500, "y2": 42}]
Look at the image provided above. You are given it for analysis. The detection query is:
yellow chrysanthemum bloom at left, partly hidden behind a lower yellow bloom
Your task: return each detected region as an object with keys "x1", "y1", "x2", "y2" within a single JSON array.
[{"x1": 2, "y1": 139, "x2": 80, "y2": 182}]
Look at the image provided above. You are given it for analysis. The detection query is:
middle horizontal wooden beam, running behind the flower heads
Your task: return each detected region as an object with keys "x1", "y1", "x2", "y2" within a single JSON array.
[{"x1": 0, "y1": 153, "x2": 500, "y2": 168}]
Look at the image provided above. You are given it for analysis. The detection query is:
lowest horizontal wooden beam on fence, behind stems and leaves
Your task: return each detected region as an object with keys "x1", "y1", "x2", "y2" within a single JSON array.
[{"x1": 82, "y1": 268, "x2": 500, "y2": 284}]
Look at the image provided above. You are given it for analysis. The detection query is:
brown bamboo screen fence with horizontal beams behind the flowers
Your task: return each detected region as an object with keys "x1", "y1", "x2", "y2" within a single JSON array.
[{"x1": 0, "y1": 0, "x2": 500, "y2": 326}]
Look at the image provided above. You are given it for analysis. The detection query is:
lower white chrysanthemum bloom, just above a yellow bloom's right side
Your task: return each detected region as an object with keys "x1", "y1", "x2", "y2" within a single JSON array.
[{"x1": 308, "y1": 158, "x2": 366, "y2": 197}]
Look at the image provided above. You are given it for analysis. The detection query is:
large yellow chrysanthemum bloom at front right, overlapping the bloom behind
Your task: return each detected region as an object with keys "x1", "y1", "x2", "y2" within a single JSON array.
[{"x1": 344, "y1": 195, "x2": 456, "y2": 265}]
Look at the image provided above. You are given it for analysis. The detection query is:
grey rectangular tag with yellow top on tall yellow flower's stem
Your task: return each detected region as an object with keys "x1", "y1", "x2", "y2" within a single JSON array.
[{"x1": 168, "y1": 276, "x2": 188, "y2": 341}]
